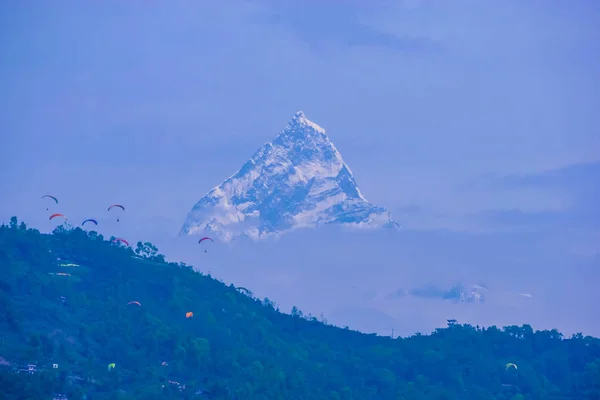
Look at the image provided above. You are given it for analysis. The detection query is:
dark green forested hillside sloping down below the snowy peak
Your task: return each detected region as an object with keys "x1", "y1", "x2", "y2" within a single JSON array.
[{"x1": 0, "y1": 218, "x2": 600, "y2": 400}]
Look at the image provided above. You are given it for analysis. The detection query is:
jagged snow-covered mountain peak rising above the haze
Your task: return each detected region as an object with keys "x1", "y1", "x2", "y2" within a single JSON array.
[{"x1": 180, "y1": 111, "x2": 398, "y2": 241}]
